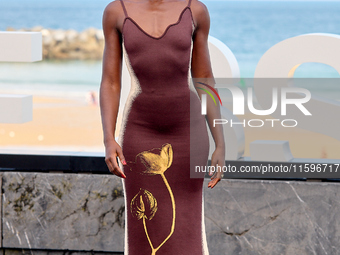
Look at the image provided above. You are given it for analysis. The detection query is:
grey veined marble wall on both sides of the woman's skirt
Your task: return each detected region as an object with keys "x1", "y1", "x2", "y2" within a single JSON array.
[{"x1": 0, "y1": 172, "x2": 340, "y2": 255}]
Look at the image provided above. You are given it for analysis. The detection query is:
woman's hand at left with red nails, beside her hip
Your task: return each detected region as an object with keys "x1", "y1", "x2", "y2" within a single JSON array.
[{"x1": 105, "y1": 141, "x2": 126, "y2": 178}]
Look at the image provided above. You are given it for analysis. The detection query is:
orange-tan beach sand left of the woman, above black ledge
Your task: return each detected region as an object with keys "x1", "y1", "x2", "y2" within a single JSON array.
[{"x1": 0, "y1": 96, "x2": 104, "y2": 151}]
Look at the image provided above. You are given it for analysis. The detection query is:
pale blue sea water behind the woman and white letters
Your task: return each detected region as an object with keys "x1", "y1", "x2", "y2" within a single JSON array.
[{"x1": 0, "y1": 0, "x2": 340, "y2": 95}]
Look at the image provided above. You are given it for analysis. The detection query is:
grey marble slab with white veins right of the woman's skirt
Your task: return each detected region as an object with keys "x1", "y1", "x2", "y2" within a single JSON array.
[{"x1": 205, "y1": 180, "x2": 340, "y2": 255}]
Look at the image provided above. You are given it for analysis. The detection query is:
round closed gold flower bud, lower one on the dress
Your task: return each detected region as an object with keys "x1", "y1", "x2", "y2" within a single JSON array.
[{"x1": 130, "y1": 188, "x2": 157, "y2": 220}]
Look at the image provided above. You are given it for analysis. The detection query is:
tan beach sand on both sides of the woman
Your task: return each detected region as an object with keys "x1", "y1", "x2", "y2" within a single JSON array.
[{"x1": 0, "y1": 96, "x2": 340, "y2": 159}]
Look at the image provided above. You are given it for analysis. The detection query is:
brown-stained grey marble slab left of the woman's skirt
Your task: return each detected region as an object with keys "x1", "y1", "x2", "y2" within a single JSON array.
[{"x1": 2, "y1": 172, "x2": 125, "y2": 252}]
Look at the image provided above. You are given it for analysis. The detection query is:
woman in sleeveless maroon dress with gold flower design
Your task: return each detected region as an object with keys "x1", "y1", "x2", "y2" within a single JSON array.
[{"x1": 100, "y1": 0, "x2": 225, "y2": 255}]
